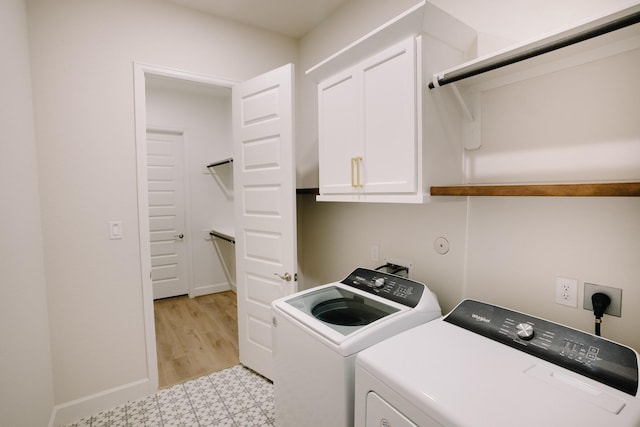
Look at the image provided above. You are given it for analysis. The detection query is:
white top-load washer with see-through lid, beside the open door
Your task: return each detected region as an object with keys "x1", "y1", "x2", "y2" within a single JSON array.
[{"x1": 272, "y1": 268, "x2": 441, "y2": 427}]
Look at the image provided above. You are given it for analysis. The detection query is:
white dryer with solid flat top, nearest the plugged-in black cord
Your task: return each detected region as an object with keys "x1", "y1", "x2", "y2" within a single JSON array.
[{"x1": 355, "y1": 300, "x2": 640, "y2": 427}]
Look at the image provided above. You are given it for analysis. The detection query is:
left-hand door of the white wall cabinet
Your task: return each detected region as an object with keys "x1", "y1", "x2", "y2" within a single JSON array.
[{"x1": 318, "y1": 70, "x2": 363, "y2": 194}]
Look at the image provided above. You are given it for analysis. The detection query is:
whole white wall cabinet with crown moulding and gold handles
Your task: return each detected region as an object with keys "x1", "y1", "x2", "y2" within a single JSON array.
[{"x1": 306, "y1": 1, "x2": 475, "y2": 203}]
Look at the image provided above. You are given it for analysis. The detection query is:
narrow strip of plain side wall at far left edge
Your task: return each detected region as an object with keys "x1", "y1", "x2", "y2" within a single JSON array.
[{"x1": 0, "y1": 0, "x2": 54, "y2": 427}]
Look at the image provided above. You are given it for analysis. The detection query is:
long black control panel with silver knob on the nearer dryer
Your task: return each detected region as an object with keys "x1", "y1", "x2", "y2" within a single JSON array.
[{"x1": 444, "y1": 300, "x2": 638, "y2": 396}]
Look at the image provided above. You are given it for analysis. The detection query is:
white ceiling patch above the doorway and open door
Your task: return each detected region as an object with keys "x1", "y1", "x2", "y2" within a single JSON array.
[{"x1": 170, "y1": 0, "x2": 348, "y2": 39}]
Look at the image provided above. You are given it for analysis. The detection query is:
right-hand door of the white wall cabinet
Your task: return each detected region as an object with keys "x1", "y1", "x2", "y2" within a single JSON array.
[{"x1": 361, "y1": 37, "x2": 420, "y2": 193}]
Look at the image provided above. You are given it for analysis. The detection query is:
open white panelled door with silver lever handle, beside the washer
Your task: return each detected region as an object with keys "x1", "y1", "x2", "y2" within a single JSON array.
[{"x1": 232, "y1": 64, "x2": 297, "y2": 378}]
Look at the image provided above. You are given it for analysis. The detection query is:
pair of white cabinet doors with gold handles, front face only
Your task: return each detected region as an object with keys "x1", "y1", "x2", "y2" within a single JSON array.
[{"x1": 318, "y1": 37, "x2": 421, "y2": 201}]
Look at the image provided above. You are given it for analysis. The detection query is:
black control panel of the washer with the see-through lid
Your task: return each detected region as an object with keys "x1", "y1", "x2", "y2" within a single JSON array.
[{"x1": 341, "y1": 268, "x2": 426, "y2": 308}]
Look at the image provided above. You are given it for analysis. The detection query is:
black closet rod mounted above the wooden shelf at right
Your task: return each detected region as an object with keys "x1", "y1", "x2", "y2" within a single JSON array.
[{"x1": 429, "y1": 11, "x2": 640, "y2": 89}]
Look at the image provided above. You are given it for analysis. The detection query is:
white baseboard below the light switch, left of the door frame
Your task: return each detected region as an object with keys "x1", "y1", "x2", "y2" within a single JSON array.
[{"x1": 49, "y1": 378, "x2": 157, "y2": 427}]
